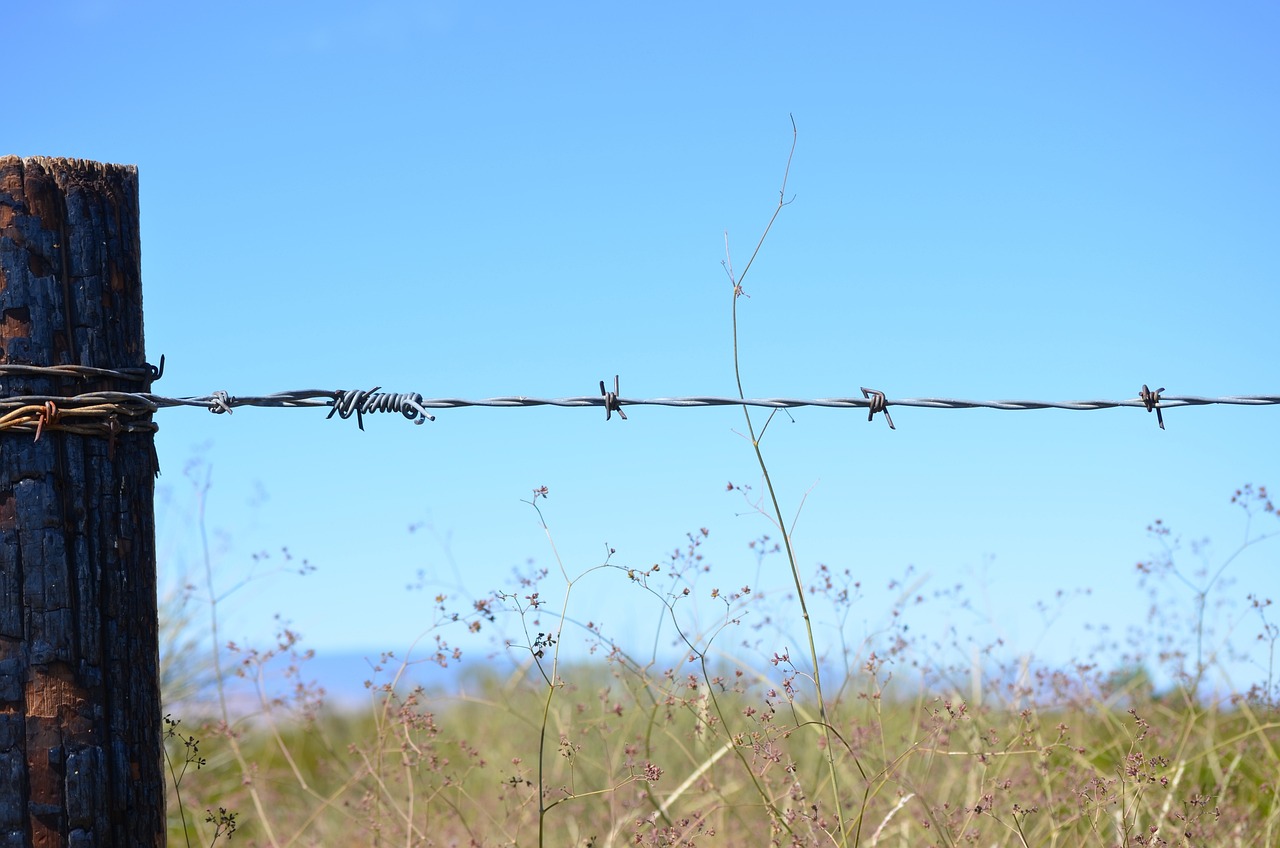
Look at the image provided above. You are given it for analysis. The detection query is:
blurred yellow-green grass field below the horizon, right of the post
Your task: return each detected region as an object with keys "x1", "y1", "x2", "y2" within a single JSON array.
[{"x1": 169, "y1": 625, "x2": 1280, "y2": 845}]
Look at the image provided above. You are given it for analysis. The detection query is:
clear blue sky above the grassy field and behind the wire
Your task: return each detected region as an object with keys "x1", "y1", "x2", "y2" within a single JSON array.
[{"x1": 0, "y1": 0, "x2": 1280, "y2": 696}]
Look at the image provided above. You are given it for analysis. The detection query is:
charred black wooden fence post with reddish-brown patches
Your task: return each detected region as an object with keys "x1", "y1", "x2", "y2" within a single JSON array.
[{"x1": 0, "y1": 156, "x2": 165, "y2": 848}]
